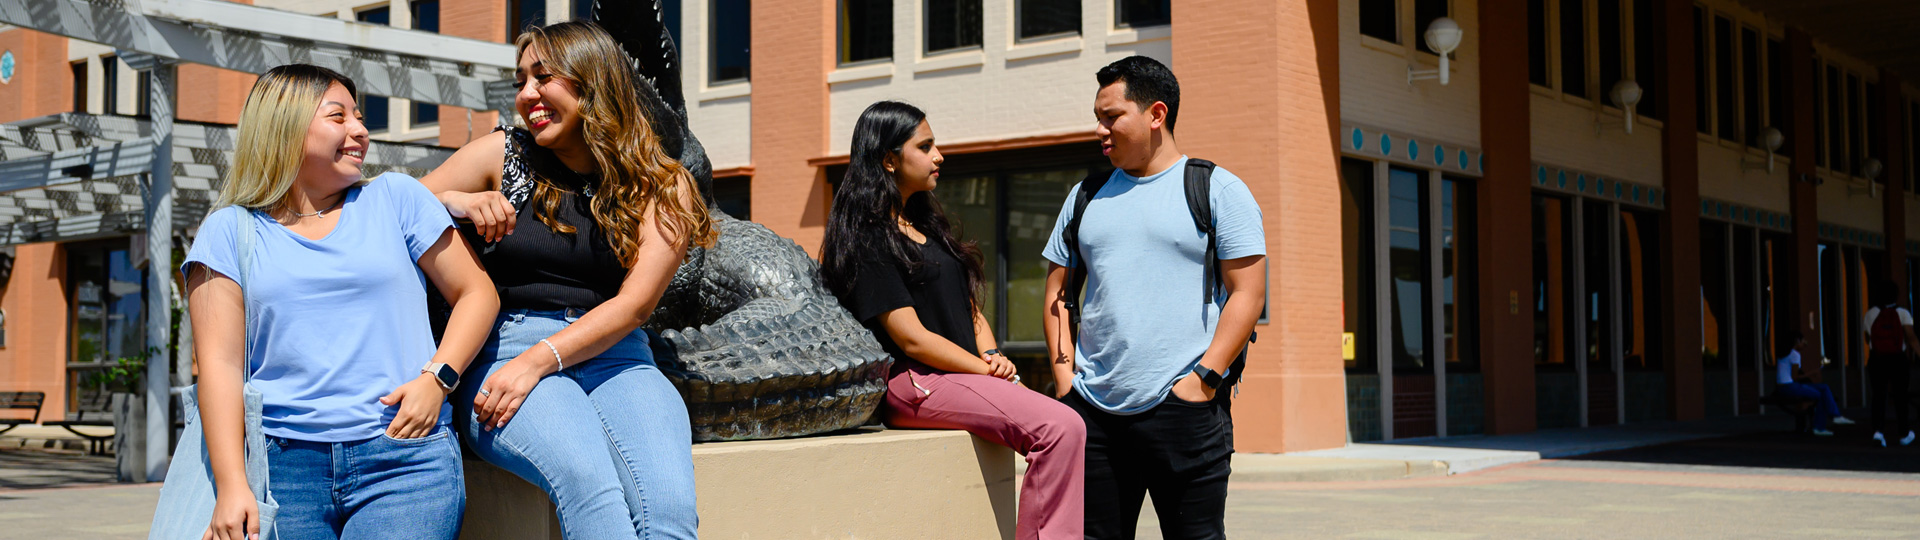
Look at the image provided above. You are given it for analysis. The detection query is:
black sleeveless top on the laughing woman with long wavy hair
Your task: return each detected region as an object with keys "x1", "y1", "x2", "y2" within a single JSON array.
[{"x1": 474, "y1": 127, "x2": 626, "y2": 309}]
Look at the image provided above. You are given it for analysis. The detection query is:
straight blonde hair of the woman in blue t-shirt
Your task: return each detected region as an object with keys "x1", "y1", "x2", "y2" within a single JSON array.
[{"x1": 215, "y1": 63, "x2": 359, "y2": 211}]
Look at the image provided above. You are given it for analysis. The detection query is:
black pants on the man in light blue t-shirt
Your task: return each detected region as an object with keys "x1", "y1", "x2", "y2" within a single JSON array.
[{"x1": 1064, "y1": 388, "x2": 1233, "y2": 540}]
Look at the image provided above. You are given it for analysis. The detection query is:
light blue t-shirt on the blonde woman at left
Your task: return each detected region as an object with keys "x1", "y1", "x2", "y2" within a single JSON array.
[{"x1": 180, "y1": 173, "x2": 453, "y2": 442}]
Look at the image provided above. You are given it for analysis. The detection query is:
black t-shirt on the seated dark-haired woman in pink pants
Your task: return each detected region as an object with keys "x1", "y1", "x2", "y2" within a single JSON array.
[{"x1": 839, "y1": 240, "x2": 979, "y2": 373}]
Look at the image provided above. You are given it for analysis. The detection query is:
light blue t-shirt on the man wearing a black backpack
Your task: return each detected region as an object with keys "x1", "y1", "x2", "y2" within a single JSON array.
[{"x1": 1043, "y1": 156, "x2": 1267, "y2": 415}]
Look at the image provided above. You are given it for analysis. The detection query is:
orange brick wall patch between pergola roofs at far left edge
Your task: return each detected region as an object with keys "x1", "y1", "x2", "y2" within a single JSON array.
[{"x1": 0, "y1": 29, "x2": 73, "y2": 123}]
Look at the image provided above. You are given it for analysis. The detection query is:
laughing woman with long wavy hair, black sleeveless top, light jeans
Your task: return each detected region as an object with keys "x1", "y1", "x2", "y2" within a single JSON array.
[{"x1": 424, "y1": 21, "x2": 714, "y2": 538}]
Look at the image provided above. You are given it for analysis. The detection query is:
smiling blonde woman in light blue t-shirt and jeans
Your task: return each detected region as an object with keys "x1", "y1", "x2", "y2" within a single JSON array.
[{"x1": 182, "y1": 65, "x2": 499, "y2": 540}]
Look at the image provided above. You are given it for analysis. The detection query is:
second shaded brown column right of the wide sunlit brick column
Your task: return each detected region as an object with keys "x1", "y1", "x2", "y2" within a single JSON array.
[{"x1": 1657, "y1": 0, "x2": 1705, "y2": 421}]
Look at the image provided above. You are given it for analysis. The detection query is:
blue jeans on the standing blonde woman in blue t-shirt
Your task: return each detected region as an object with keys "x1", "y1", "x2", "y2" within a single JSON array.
[{"x1": 267, "y1": 427, "x2": 467, "y2": 540}]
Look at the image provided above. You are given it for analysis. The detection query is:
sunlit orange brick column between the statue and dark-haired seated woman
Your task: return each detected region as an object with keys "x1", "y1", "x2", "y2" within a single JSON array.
[{"x1": 751, "y1": 0, "x2": 833, "y2": 258}]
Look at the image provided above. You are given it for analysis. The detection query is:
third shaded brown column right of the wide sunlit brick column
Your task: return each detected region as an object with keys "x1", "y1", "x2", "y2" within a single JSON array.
[{"x1": 1788, "y1": 27, "x2": 1820, "y2": 357}]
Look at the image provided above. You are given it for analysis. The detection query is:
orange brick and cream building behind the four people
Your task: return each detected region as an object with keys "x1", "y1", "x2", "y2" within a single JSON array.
[{"x1": 0, "y1": 0, "x2": 1920, "y2": 452}]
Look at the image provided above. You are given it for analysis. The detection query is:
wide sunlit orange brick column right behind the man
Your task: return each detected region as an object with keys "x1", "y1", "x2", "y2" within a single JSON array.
[{"x1": 1159, "y1": 0, "x2": 1346, "y2": 452}]
